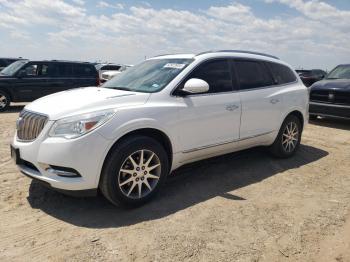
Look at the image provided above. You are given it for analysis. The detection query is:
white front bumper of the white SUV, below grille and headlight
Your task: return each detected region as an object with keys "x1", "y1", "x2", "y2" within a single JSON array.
[{"x1": 12, "y1": 121, "x2": 110, "y2": 194}]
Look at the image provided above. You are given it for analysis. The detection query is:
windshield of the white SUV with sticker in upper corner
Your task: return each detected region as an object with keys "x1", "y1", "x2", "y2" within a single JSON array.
[{"x1": 102, "y1": 59, "x2": 193, "y2": 93}]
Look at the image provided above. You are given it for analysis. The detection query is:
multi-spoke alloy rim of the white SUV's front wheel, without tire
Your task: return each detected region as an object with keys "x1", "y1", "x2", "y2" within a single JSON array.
[{"x1": 118, "y1": 149, "x2": 161, "y2": 199}]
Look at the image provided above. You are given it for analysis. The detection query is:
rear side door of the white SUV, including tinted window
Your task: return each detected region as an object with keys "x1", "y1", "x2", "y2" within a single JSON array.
[{"x1": 234, "y1": 59, "x2": 283, "y2": 139}]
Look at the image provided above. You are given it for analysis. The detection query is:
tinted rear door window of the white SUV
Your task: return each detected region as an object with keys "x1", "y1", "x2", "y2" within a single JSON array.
[{"x1": 235, "y1": 60, "x2": 274, "y2": 90}]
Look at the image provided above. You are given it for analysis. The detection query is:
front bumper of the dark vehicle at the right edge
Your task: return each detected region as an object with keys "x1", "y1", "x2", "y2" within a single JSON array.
[{"x1": 309, "y1": 102, "x2": 350, "y2": 119}]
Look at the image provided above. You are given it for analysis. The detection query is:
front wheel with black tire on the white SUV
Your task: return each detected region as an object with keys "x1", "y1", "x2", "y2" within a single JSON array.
[{"x1": 99, "y1": 136, "x2": 169, "y2": 207}]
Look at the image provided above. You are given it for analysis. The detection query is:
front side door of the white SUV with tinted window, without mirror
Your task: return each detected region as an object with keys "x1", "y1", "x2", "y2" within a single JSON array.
[{"x1": 177, "y1": 59, "x2": 241, "y2": 156}]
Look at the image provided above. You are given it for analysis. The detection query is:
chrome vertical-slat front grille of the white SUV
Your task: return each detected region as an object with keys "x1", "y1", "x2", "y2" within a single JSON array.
[{"x1": 16, "y1": 110, "x2": 48, "y2": 141}]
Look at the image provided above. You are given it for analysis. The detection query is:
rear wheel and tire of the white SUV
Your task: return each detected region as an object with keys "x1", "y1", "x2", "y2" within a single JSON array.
[{"x1": 270, "y1": 115, "x2": 303, "y2": 158}]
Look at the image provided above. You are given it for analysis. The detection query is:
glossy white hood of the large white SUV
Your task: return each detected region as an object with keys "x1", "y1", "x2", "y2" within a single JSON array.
[{"x1": 25, "y1": 87, "x2": 150, "y2": 120}]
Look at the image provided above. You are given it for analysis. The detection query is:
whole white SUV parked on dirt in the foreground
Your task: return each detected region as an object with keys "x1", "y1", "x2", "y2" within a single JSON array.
[{"x1": 11, "y1": 51, "x2": 308, "y2": 205}]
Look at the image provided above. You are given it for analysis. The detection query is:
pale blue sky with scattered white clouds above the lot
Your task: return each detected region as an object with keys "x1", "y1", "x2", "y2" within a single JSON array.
[{"x1": 0, "y1": 0, "x2": 350, "y2": 70}]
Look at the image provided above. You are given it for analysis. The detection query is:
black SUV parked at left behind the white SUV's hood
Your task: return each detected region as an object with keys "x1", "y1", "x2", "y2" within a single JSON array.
[{"x1": 0, "y1": 60, "x2": 100, "y2": 111}]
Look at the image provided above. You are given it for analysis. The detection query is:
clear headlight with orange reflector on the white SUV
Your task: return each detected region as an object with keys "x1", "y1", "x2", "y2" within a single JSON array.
[{"x1": 49, "y1": 110, "x2": 115, "y2": 139}]
